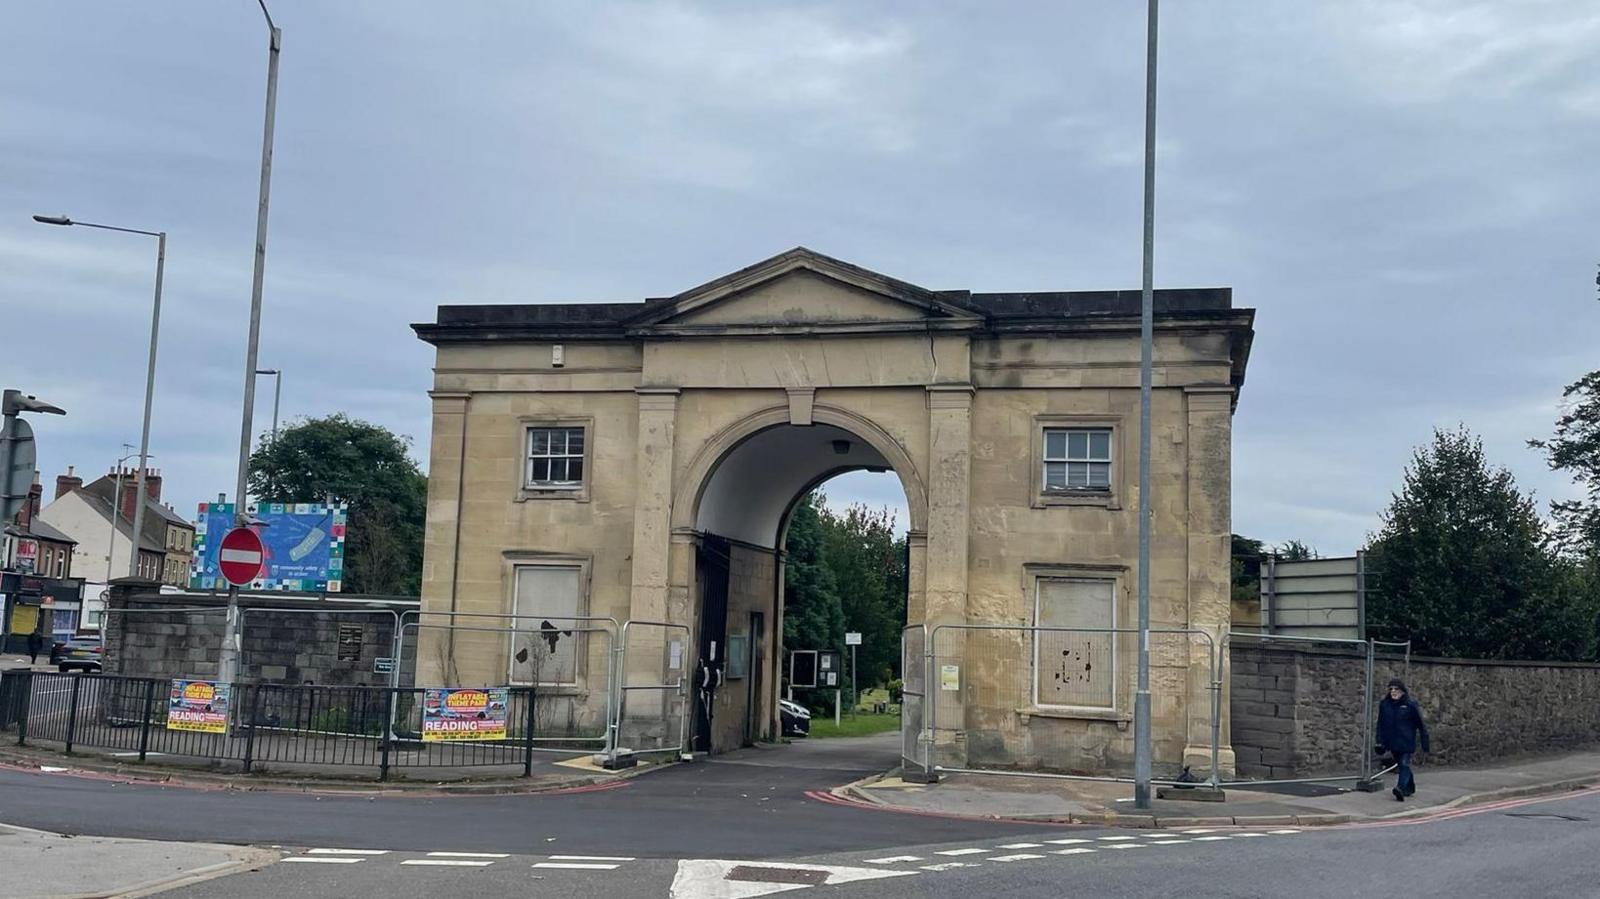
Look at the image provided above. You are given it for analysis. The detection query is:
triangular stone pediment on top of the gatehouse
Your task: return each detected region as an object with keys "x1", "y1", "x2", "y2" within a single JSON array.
[{"x1": 630, "y1": 248, "x2": 981, "y2": 333}]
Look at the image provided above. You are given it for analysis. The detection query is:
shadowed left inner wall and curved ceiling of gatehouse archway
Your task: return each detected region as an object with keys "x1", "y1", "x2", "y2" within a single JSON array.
[{"x1": 691, "y1": 422, "x2": 915, "y2": 752}]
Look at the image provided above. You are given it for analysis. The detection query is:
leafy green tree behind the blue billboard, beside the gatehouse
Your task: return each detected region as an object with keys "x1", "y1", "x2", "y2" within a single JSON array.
[{"x1": 250, "y1": 413, "x2": 427, "y2": 597}]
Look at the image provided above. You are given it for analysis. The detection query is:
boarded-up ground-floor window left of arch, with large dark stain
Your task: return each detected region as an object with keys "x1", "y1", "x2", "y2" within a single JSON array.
[{"x1": 510, "y1": 565, "x2": 582, "y2": 686}]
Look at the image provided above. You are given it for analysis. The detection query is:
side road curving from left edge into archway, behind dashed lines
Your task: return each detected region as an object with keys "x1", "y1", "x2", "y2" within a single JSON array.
[{"x1": 0, "y1": 734, "x2": 1062, "y2": 867}]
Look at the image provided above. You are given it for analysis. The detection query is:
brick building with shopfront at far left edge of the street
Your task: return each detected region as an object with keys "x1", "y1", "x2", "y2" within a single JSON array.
[{"x1": 0, "y1": 472, "x2": 83, "y2": 653}]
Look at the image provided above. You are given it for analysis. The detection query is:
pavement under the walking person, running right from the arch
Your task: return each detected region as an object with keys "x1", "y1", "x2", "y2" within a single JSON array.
[{"x1": 837, "y1": 752, "x2": 1600, "y2": 827}]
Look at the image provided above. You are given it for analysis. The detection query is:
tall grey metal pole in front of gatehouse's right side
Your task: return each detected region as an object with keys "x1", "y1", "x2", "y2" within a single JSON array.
[{"x1": 1133, "y1": 0, "x2": 1158, "y2": 809}]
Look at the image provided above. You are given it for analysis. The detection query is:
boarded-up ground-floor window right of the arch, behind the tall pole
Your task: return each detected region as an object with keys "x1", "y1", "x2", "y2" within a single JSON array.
[{"x1": 1034, "y1": 576, "x2": 1117, "y2": 710}]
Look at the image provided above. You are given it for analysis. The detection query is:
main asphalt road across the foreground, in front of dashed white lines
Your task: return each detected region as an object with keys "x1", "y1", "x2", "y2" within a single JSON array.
[{"x1": 165, "y1": 793, "x2": 1600, "y2": 899}]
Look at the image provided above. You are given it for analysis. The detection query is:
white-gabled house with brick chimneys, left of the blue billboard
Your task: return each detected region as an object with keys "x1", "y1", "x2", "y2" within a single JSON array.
[{"x1": 40, "y1": 467, "x2": 195, "y2": 627}]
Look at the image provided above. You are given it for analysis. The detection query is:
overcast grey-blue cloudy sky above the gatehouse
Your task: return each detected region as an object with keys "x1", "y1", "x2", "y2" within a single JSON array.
[{"x1": 0, "y1": 0, "x2": 1600, "y2": 553}]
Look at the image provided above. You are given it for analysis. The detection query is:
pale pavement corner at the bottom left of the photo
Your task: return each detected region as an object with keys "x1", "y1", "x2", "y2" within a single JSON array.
[{"x1": 0, "y1": 824, "x2": 280, "y2": 899}]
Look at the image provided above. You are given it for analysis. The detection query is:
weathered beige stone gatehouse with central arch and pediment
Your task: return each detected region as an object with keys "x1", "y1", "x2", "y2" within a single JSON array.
[{"x1": 414, "y1": 248, "x2": 1254, "y2": 769}]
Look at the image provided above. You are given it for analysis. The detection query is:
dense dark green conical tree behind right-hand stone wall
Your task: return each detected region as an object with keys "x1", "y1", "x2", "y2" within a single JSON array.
[{"x1": 1368, "y1": 429, "x2": 1595, "y2": 659}]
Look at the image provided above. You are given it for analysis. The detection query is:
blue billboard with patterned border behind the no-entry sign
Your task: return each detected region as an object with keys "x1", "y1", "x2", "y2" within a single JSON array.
[{"x1": 189, "y1": 502, "x2": 346, "y2": 593}]
